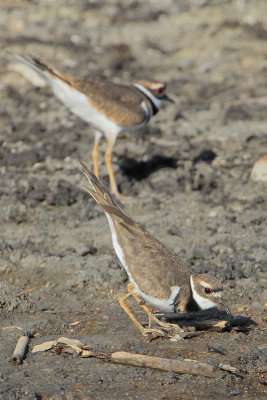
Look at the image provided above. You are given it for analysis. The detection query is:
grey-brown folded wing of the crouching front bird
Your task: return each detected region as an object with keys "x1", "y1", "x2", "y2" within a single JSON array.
[{"x1": 110, "y1": 217, "x2": 190, "y2": 298}]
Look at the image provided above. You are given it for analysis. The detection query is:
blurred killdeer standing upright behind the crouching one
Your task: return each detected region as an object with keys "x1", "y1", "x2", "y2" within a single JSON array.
[{"x1": 15, "y1": 56, "x2": 173, "y2": 200}]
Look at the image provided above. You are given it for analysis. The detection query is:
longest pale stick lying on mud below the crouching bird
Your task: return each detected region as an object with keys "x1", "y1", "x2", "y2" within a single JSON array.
[{"x1": 110, "y1": 351, "x2": 223, "y2": 378}]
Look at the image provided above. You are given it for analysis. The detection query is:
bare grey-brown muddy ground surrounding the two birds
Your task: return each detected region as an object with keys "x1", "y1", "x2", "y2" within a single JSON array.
[{"x1": 0, "y1": 0, "x2": 267, "y2": 399}]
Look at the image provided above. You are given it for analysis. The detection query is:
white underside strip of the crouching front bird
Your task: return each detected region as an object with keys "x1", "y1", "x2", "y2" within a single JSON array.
[{"x1": 105, "y1": 212, "x2": 180, "y2": 312}]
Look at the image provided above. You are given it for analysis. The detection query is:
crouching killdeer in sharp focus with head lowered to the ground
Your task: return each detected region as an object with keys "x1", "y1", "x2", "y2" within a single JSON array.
[{"x1": 82, "y1": 163, "x2": 230, "y2": 335}]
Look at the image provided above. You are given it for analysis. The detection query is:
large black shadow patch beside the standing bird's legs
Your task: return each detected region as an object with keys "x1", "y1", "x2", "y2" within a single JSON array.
[{"x1": 120, "y1": 154, "x2": 177, "y2": 181}]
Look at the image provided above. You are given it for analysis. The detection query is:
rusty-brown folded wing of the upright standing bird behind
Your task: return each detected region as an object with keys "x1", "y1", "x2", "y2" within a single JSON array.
[{"x1": 73, "y1": 78, "x2": 149, "y2": 126}]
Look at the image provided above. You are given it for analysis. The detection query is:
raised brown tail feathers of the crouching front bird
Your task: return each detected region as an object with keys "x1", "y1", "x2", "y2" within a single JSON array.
[{"x1": 81, "y1": 162, "x2": 135, "y2": 225}]
